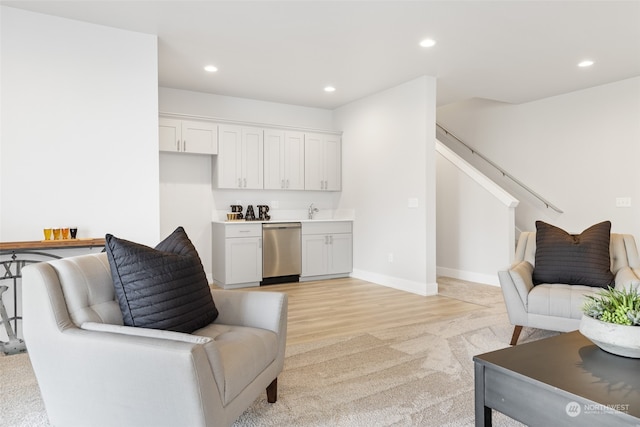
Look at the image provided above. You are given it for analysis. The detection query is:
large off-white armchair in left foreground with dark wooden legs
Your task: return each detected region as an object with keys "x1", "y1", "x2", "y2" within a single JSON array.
[{"x1": 23, "y1": 253, "x2": 287, "y2": 427}]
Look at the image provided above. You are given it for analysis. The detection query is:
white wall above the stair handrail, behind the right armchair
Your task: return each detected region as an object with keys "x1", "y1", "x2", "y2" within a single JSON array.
[{"x1": 437, "y1": 77, "x2": 640, "y2": 242}]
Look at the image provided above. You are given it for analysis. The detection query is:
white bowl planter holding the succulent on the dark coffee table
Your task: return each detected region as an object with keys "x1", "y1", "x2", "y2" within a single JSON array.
[{"x1": 580, "y1": 314, "x2": 640, "y2": 358}]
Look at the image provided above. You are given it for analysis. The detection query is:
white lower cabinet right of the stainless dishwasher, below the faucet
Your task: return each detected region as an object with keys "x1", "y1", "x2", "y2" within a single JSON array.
[{"x1": 301, "y1": 221, "x2": 353, "y2": 280}]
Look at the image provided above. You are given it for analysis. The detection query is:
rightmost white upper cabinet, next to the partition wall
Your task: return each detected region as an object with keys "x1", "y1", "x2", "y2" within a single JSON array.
[{"x1": 304, "y1": 133, "x2": 342, "y2": 191}]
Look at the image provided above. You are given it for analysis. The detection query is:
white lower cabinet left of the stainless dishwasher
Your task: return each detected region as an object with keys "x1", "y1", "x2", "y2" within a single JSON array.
[{"x1": 212, "y1": 223, "x2": 262, "y2": 289}]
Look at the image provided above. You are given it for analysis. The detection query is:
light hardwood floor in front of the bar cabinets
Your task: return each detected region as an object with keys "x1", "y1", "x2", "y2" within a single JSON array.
[{"x1": 240, "y1": 278, "x2": 496, "y2": 344}]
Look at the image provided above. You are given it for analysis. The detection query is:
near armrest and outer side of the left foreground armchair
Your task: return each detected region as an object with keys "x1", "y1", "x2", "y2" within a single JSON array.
[{"x1": 27, "y1": 327, "x2": 223, "y2": 425}]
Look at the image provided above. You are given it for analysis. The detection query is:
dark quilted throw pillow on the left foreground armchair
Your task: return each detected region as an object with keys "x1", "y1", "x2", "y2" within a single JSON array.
[{"x1": 105, "y1": 227, "x2": 218, "y2": 333}]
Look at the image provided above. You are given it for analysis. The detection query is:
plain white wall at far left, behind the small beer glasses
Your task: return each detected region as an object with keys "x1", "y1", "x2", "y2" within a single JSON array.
[{"x1": 0, "y1": 7, "x2": 159, "y2": 245}]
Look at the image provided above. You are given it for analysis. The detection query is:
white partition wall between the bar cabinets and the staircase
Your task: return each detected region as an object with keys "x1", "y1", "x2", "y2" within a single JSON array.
[{"x1": 334, "y1": 77, "x2": 437, "y2": 295}]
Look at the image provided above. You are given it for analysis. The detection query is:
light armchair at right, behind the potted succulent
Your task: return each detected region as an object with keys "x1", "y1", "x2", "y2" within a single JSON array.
[{"x1": 498, "y1": 232, "x2": 640, "y2": 345}]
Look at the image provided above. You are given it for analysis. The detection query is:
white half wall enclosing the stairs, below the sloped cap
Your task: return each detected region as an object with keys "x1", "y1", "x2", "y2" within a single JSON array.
[{"x1": 436, "y1": 148, "x2": 518, "y2": 285}]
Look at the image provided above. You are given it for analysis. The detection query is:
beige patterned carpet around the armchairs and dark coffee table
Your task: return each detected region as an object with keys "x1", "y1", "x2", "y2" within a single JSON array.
[{"x1": 0, "y1": 279, "x2": 555, "y2": 427}]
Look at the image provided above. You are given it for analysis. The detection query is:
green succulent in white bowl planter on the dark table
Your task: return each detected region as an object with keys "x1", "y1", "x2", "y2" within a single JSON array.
[{"x1": 580, "y1": 288, "x2": 640, "y2": 358}]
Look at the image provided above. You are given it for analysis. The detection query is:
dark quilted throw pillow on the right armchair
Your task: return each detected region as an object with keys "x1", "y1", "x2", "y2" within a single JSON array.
[{"x1": 533, "y1": 221, "x2": 614, "y2": 288}]
